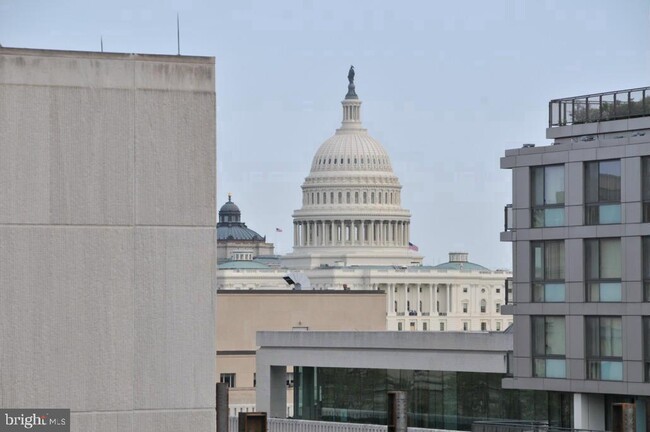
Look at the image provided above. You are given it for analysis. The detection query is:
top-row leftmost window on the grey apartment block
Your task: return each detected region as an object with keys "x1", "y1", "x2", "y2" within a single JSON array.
[{"x1": 530, "y1": 165, "x2": 564, "y2": 227}]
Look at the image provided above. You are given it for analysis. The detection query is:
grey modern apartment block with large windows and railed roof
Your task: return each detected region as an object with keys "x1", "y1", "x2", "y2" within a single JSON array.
[{"x1": 501, "y1": 88, "x2": 650, "y2": 431}]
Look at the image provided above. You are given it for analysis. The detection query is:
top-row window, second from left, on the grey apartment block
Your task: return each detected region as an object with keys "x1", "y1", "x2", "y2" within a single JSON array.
[{"x1": 585, "y1": 160, "x2": 621, "y2": 225}]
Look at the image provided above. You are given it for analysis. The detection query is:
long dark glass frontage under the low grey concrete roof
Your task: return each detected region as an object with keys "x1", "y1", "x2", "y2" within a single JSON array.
[{"x1": 294, "y1": 367, "x2": 573, "y2": 430}]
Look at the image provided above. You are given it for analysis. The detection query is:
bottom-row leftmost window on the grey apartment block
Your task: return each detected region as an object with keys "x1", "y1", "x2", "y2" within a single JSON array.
[{"x1": 531, "y1": 316, "x2": 566, "y2": 378}]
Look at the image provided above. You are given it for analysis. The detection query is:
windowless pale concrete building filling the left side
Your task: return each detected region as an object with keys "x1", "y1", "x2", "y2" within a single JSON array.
[{"x1": 0, "y1": 48, "x2": 216, "y2": 432}]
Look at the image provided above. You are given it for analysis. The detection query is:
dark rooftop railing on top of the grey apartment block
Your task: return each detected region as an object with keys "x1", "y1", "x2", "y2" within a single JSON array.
[{"x1": 548, "y1": 87, "x2": 650, "y2": 127}]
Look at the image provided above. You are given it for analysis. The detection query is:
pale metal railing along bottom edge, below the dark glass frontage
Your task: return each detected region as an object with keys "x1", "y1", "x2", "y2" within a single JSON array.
[{"x1": 228, "y1": 417, "x2": 456, "y2": 432}]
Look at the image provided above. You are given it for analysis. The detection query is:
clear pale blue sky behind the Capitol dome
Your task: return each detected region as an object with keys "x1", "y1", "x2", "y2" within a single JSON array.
[{"x1": 0, "y1": 0, "x2": 650, "y2": 268}]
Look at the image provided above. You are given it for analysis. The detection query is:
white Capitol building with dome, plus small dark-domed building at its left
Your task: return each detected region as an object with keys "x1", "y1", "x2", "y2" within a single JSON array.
[{"x1": 217, "y1": 68, "x2": 512, "y2": 331}]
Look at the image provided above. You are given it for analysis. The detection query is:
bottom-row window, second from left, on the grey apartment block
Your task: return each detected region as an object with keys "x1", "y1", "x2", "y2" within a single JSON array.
[{"x1": 585, "y1": 317, "x2": 623, "y2": 381}]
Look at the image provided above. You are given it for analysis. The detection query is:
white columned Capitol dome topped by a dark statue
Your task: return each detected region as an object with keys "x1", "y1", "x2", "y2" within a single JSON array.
[{"x1": 283, "y1": 68, "x2": 422, "y2": 268}]
